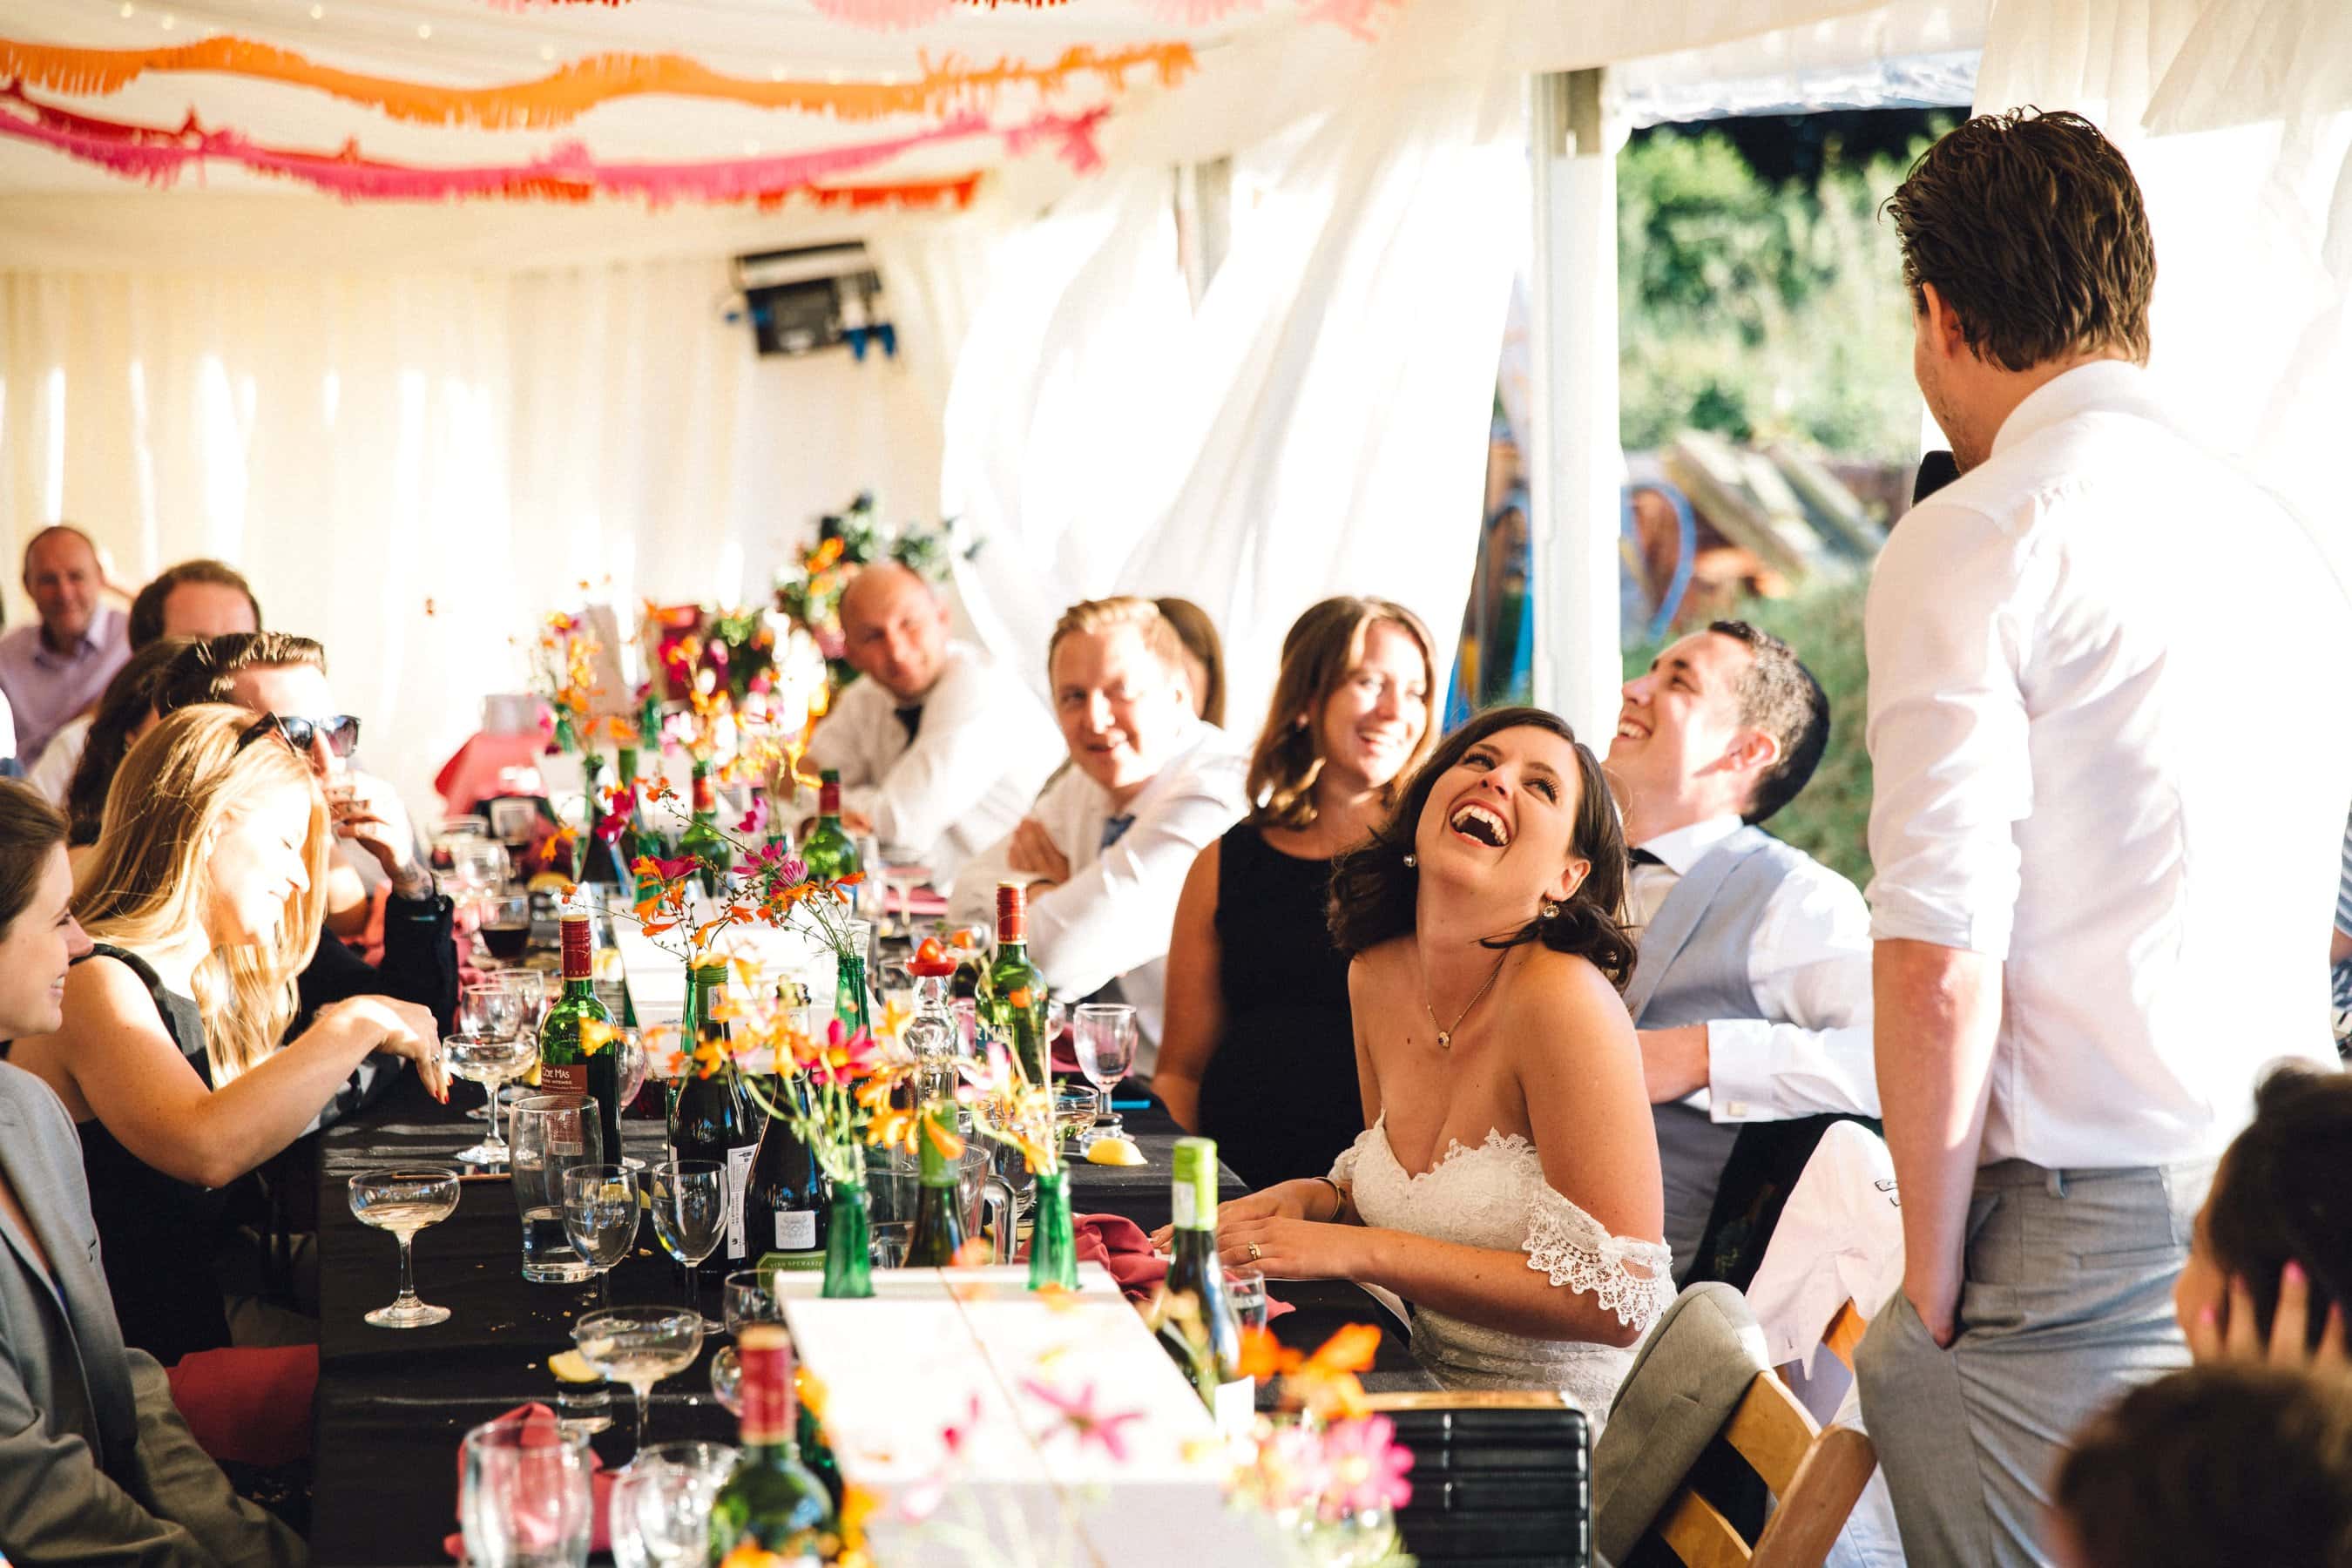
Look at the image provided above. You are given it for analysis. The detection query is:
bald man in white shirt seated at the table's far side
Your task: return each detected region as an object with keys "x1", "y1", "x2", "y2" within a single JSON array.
[{"x1": 809, "y1": 562, "x2": 1061, "y2": 896}]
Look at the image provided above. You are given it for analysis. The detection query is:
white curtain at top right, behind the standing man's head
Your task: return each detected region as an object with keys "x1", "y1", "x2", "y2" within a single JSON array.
[{"x1": 1976, "y1": 0, "x2": 2352, "y2": 562}]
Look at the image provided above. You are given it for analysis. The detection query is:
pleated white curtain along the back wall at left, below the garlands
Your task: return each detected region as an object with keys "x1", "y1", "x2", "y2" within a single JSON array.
[{"x1": 0, "y1": 261, "x2": 938, "y2": 814}]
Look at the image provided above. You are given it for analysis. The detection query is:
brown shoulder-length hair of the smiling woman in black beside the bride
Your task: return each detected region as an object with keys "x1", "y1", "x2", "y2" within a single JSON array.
[{"x1": 1249, "y1": 597, "x2": 1437, "y2": 830}]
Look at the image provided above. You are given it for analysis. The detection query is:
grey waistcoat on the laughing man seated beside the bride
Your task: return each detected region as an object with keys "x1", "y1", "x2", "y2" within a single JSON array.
[{"x1": 1625, "y1": 825, "x2": 1804, "y2": 1279}]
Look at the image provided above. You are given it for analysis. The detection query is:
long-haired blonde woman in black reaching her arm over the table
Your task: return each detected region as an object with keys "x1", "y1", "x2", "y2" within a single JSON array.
[{"x1": 10, "y1": 703, "x2": 447, "y2": 1363}]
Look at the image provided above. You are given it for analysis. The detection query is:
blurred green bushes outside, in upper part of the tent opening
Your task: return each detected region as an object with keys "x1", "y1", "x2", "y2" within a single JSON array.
[{"x1": 1619, "y1": 127, "x2": 1926, "y2": 461}]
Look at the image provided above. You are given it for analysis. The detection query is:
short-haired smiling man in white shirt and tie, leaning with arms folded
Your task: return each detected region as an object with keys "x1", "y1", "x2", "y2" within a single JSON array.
[{"x1": 950, "y1": 599, "x2": 1249, "y2": 1077}]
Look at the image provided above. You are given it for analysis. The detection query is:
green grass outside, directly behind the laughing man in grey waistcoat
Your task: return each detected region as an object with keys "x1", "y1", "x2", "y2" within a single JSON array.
[{"x1": 1625, "y1": 578, "x2": 1870, "y2": 886}]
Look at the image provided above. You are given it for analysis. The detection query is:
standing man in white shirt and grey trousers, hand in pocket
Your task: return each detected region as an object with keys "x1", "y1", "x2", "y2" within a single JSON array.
[{"x1": 1855, "y1": 113, "x2": 2352, "y2": 1568}]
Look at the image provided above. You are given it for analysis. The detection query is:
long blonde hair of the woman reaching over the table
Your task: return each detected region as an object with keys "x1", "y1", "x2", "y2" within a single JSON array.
[{"x1": 73, "y1": 703, "x2": 332, "y2": 1088}]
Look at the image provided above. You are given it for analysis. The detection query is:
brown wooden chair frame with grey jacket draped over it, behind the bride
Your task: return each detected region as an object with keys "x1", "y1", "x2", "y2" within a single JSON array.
[{"x1": 1651, "y1": 1302, "x2": 1879, "y2": 1568}]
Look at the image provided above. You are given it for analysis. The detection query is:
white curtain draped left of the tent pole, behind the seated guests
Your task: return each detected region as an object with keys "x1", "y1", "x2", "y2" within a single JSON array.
[{"x1": 884, "y1": 9, "x2": 1529, "y2": 733}]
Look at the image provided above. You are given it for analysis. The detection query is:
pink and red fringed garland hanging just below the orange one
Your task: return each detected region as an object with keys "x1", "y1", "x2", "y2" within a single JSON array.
[{"x1": 0, "y1": 82, "x2": 1110, "y2": 206}]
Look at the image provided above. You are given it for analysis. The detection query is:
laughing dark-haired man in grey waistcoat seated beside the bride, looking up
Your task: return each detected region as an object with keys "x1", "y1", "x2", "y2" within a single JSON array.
[{"x1": 1609, "y1": 620, "x2": 1879, "y2": 1288}]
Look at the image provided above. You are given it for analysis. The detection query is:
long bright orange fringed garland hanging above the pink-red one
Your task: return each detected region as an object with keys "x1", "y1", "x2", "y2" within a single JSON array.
[{"x1": 0, "y1": 37, "x2": 1195, "y2": 129}]
